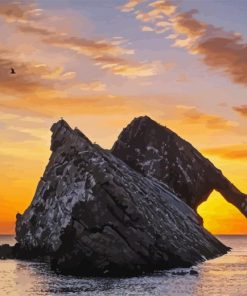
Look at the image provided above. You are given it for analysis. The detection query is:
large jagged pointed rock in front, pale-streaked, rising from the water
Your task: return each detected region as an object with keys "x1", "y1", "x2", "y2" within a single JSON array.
[{"x1": 16, "y1": 120, "x2": 228, "y2": 276}]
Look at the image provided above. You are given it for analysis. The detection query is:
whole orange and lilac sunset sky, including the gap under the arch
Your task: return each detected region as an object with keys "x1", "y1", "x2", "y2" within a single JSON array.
[{"x1": 0, "y1": 0, "x2": 247, "y2": 234}]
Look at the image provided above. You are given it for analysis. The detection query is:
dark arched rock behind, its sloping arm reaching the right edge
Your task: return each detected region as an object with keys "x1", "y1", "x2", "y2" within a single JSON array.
[{"x1": 112, "y1": 116, "x2": 247, "y2": 216}]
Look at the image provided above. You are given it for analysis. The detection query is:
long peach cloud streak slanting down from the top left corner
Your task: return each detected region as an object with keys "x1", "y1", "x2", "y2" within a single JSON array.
[{"x1": 0, "y1": 1, "x2": 160, "y2": 78}]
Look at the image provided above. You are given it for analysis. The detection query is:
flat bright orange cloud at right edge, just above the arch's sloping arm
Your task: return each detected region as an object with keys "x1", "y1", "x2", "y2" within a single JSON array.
[{"x1": 202, "y1": 144, "x2": 247, "y2": 160}]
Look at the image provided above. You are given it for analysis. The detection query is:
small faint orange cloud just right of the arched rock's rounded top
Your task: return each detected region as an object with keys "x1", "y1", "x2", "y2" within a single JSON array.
[{"x1": 177, "y1": 105, "x2": 238, "y2": 130}]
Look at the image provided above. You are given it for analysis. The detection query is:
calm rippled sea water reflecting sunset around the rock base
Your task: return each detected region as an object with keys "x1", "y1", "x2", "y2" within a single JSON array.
[{"x1": 0, "y1": 236, "x2": 247, "y2": 296}]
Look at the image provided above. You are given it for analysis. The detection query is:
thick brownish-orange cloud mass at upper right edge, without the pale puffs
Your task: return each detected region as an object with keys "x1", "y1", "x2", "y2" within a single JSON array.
[{"x1": 172, "y1": 11, "x2": 247, "y2": 85}]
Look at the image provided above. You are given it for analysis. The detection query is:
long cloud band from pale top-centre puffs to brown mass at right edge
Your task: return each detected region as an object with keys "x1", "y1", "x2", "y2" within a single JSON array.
[{"x1": 121, "y1": 0, "x2": 247, "y2": 86}]
